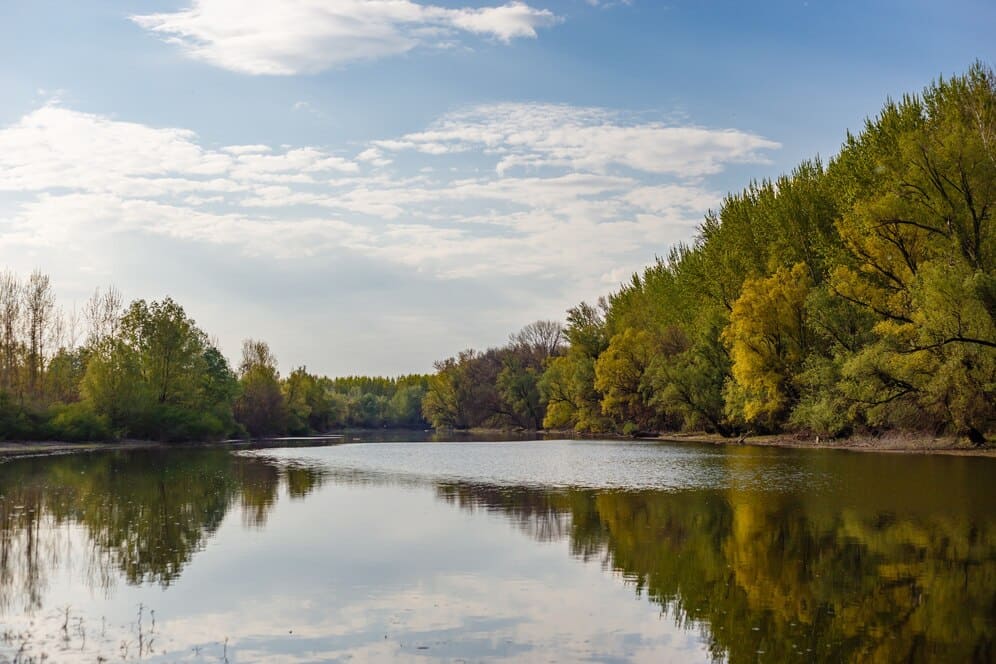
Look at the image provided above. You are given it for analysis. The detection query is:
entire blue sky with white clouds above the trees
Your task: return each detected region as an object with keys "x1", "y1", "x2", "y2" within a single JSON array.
[{"x1": 0, "y1": 0, "x2": 996, "y2": 375}]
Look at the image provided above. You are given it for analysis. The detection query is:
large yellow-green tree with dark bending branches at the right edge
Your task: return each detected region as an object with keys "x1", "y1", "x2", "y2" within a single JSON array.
[{"x1": 832, "y1": 64, "x2": 996, "y2": 440}]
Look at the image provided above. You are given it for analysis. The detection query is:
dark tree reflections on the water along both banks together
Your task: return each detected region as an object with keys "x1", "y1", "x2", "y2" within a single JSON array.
[{"x1": 0, "y1": 450, "x2": 996, "y2": 662}]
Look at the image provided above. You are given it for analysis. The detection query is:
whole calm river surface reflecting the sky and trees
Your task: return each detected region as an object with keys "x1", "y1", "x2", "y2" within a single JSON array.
[{"x1": 0, "y1": 438, "x2": 996, "y2": 663}]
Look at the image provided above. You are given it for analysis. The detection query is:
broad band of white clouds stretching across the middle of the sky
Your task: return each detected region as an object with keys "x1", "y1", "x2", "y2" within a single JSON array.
[{"x1": 0, "y1": 104, "x2": 777, "y2": 275}]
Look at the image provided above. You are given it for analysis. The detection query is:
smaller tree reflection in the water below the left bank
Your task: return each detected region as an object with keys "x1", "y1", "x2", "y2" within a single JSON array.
[{"x1": 0, "y1": 450, "x2": 323, "y2": 616}]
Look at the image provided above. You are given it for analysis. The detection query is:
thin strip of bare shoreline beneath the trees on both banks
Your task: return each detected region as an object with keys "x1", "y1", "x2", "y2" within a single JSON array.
[{"x1": 0, "y1": 429, "x2": 996, "y2": 461}]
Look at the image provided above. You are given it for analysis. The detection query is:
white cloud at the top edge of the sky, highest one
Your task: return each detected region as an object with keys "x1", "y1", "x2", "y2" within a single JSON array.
[{"x1": 131, "y1": 0, "x2": 560, "y2": 75}]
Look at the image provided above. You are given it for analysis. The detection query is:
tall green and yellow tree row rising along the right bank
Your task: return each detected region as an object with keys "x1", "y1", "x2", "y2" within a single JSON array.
[{"x1": 424, "y1": 64, "x2": 996, "y2": 442}]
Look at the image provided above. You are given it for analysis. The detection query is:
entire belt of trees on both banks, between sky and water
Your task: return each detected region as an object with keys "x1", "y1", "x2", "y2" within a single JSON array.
[{"x1": 0, "y1": 63, "x2": 996, "y2": 443}]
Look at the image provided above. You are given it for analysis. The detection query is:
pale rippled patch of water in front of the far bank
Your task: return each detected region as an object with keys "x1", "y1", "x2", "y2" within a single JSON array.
[{"x1": 246, "y1": 440, "x2": 827, "y2": 491}]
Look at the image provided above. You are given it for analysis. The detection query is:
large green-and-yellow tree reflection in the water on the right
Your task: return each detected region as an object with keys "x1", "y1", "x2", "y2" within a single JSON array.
[{"x1": 437, "y1": 453, "x2": 996, "y2": 662}]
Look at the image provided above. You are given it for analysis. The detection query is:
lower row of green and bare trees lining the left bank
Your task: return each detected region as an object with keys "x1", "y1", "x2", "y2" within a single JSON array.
[{"x1": 0, "y1": 280, "x2": 428, "y2": 440}]
